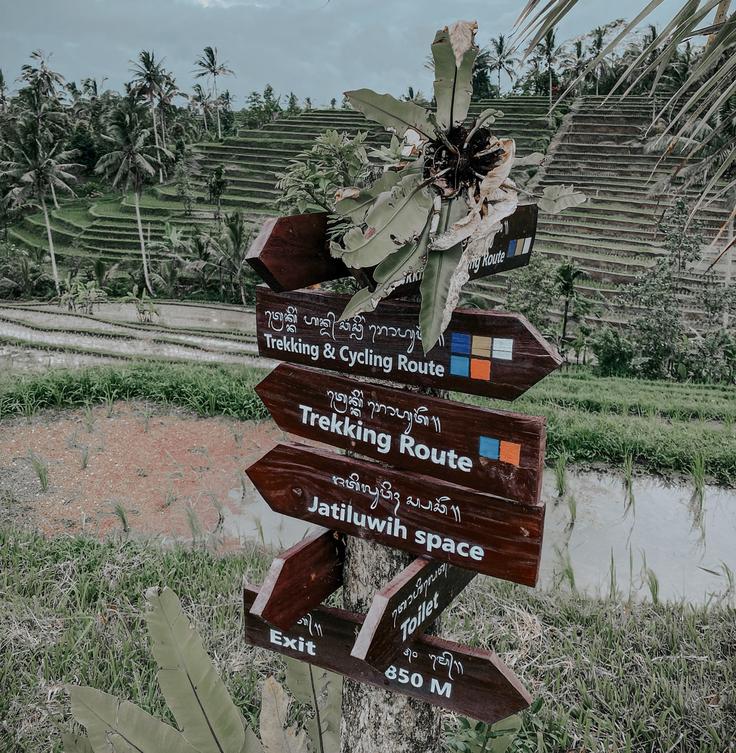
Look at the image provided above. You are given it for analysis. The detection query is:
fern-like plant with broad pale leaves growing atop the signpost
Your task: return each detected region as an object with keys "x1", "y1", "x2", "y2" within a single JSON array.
[{"x1": 330, "y1": 21, "x2": 585, "y2": 353}]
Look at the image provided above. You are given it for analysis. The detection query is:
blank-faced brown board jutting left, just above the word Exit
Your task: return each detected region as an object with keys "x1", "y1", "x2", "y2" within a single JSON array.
[{"x1": 253, "y1": 531, "x2": 345, "y2": 630}]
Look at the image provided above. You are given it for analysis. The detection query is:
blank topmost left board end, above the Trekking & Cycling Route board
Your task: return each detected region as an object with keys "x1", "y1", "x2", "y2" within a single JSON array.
[{"x1": 246, "y1": 212, "x2": 350, "y2": 290}]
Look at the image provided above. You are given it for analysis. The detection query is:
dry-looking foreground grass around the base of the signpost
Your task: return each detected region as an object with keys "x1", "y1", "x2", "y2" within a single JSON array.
[{"x1": 0, "y1": 529, "x2": 736, "y2": 753}]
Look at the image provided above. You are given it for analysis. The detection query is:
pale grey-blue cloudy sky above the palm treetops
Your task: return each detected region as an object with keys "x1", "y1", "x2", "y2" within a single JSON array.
[{"x1": 0, "y1": 0, "x2": 680, "y2": 107}]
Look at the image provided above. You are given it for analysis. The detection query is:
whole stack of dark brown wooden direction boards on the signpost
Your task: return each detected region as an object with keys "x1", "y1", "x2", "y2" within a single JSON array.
[{"x1": 244, "y1": 205, "x2": 561, "y2": 736}]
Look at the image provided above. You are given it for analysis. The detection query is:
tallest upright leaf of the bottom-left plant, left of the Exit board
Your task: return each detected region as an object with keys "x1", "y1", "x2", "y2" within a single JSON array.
[{"x1": 146, "y1": 588, "x2": 245, "y2": 753}]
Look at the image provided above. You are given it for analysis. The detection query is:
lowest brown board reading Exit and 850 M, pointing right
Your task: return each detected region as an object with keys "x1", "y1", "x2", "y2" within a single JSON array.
[{"x1": 243, "y1": 586, "x2": 531, "y2": 724}]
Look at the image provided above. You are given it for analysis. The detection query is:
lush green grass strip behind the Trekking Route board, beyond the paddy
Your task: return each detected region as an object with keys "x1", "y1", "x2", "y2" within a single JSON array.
[{"x1": 0, "y1": 363, "x2": 736, "y2": 485}]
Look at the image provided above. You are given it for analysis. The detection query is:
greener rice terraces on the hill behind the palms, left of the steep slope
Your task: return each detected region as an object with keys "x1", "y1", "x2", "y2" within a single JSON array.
[{"x1": 10, "y1": 97, "x2": 554, "y2": 266}]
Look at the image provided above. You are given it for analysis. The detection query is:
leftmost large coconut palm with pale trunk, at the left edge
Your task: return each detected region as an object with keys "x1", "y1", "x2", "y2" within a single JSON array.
[{"x1": 0, "y1": 138, "x2": 79, "y2": 295}]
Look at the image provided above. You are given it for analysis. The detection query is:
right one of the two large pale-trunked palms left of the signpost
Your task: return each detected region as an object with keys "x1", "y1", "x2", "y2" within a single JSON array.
[{"x1": 95, "y1": 100, "x2": 173, "y2": 295}]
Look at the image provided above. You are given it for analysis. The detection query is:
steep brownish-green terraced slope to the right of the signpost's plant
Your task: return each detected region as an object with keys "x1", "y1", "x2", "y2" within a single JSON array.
[{"x1": 468, "y1": 97, "x2": 729, "y2": 320}]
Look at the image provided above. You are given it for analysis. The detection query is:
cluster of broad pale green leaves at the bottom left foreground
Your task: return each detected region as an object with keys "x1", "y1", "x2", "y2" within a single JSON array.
[{"x1": 62, "y1": 588, "x2": 342, "y2": 753}]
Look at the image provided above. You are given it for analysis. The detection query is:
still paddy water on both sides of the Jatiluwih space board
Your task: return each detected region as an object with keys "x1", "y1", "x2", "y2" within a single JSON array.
[{"x1": 224, "y1": 470, "x2": 736, "y2": 604}]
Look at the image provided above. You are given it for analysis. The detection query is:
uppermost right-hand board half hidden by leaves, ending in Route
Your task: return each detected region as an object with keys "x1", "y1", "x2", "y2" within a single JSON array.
[{"x1": 392, "y1": 204, "x2": 539, "y2": 298}]
